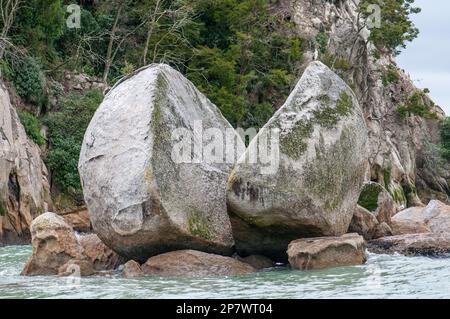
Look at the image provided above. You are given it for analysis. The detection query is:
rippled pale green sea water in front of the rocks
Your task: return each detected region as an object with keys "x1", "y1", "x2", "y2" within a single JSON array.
[{"x1": 0, "y1": 246, "x2": 450, "y2": 299}]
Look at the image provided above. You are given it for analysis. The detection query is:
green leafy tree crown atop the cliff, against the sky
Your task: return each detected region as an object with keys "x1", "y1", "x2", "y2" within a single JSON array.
[{"x1": 359, "y1": 0, "x2": 420, "y2": 54}]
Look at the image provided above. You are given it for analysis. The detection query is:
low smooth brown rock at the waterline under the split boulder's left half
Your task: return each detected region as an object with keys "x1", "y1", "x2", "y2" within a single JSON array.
[{"x1": 141, "y1": 250, "x2": 256, "y2": 277}]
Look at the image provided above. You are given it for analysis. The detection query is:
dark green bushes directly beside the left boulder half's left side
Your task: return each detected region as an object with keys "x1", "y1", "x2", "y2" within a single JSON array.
[{"x1": 44, "y1": 90, "x2": 103, "y2": 193}]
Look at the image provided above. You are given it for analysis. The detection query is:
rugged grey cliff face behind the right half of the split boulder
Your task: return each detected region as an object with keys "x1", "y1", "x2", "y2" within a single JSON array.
[{"x1": 277, "y1": 0, "x2": 449, "y2": 208}]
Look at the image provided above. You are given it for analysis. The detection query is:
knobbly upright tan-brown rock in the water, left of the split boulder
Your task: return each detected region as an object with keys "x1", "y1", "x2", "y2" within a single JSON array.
[{"x1": 22, "y1": 213, "x2": 87, "y2": 276}]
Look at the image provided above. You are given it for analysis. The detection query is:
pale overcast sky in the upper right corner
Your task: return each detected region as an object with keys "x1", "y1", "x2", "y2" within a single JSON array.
[{"x1": 397, "y1": 0, "x2": 450, "y2": 115}]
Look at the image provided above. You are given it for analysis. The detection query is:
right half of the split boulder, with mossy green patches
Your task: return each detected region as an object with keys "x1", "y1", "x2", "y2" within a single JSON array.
[{"x1": 227, "y1": 62, "x2": 367, "y2": 259}]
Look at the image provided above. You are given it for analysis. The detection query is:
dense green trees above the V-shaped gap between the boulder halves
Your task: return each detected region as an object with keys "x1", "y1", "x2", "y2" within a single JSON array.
[{"x1": 187, "y1": 0, "x2": 303, "y2": 127}]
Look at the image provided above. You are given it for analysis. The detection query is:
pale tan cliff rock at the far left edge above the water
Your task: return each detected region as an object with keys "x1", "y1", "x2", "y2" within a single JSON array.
[{"x1": 0, "y1": 83, "x2": 51, "y2": 245}]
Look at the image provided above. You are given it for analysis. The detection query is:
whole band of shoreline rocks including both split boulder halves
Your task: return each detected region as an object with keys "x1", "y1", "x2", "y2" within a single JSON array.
[{"x1": 15, "y1": 62, "x2": 450, "y2": 278}]
